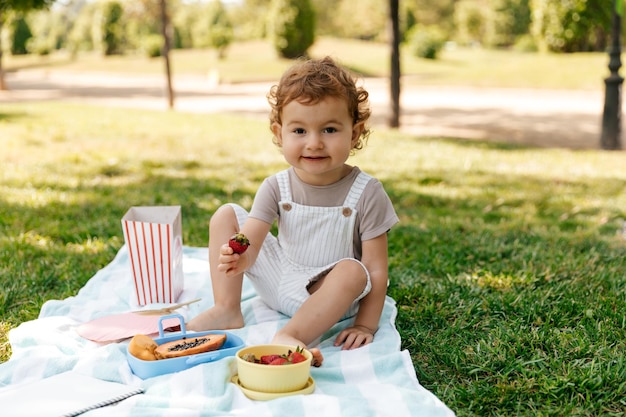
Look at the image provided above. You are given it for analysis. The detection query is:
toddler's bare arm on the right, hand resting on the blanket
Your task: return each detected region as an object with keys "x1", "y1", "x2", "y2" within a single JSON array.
[{"x1": 335, "y1": 233, "x2": 389, "y2": 349}]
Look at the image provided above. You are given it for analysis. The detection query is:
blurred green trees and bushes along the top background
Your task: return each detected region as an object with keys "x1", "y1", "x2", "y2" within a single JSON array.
[{"x1": 0, "y1": 0, "x2": 612, "y2": 63}]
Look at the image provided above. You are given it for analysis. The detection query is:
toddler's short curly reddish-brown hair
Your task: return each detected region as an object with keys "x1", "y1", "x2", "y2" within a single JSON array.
[{"x1": 267, "y1": 57, "x2": 371, "y2": 150}]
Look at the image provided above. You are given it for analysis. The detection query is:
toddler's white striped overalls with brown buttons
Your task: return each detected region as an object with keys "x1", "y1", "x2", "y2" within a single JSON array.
[{"x1": 233, "y1": 170, "x2": 371, "y2": 317}]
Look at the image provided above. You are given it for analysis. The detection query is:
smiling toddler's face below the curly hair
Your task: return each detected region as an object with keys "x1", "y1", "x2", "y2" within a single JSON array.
[{"x1": 272, "y1": 97, "x2": 363, "y2": 185}]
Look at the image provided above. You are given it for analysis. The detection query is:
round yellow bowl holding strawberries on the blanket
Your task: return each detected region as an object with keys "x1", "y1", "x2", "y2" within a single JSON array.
[{"x1": 236, "y1": 345, "x2": 313, "y2": 393}]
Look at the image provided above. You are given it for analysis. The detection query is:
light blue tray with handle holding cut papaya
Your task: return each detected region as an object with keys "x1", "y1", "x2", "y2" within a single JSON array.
[{"x1": 126, "y1": 314, "x2": 244, "y2": 379}]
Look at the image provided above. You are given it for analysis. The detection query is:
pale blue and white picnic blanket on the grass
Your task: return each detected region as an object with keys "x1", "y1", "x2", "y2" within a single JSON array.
[{"x1": 0, "y1": 247, "x2": 454, "y2": 417}]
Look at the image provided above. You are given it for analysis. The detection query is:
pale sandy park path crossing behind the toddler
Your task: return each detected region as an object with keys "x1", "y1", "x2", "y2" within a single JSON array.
[{"x1": 0, "y1": 69, "x2": 604, "y2": 149}]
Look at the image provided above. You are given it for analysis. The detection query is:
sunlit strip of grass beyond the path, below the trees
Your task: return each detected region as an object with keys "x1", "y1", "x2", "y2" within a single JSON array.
[{"x1": 4, "y1": 38, "x2": 609, "y2": 90}]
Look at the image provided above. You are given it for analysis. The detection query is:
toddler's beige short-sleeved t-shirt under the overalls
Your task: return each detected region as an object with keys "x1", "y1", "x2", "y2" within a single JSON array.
[{"x1": 250, "y1": 167, "x2": 399, "y2": 259}]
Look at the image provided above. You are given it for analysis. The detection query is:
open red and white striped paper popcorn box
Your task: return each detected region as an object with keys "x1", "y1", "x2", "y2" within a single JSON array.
[{"x1": 122, "y1": 206, "x2": 184, "y2": 306}]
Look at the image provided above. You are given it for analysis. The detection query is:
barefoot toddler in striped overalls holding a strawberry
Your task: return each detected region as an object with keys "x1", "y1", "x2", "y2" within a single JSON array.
[{"x1": 187, "y1": 57, "x2": 398, "y2": 366}]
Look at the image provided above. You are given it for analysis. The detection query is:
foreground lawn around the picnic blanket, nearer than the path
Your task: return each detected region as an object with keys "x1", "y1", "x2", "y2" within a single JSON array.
[{"x1": 0, "y1": 38, "x2": 626, "y2": 416}]
